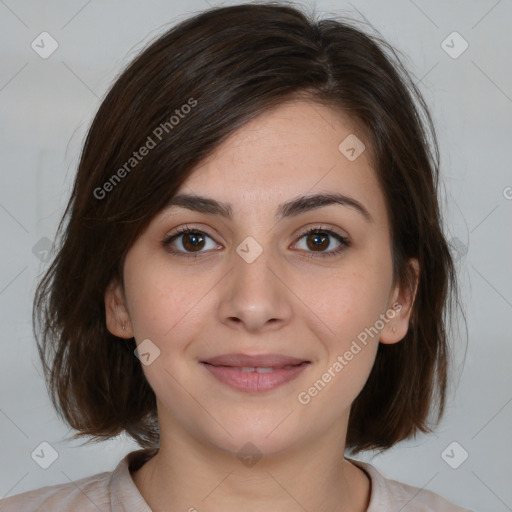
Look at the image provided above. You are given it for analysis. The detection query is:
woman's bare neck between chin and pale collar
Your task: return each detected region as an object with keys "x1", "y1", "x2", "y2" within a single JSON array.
[{"x1": 132, "y1": 420, "x2": 370, "y2": 512}]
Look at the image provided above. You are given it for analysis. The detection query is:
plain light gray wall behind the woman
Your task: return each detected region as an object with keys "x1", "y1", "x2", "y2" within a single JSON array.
[{"x1": 0, "y1": 0, "x2": 512, "y2": 512}]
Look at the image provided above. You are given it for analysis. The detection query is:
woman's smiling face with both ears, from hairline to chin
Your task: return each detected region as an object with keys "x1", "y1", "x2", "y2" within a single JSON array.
[{"x1": 105, "y1": 100, "x2": 415, "y2": 453}]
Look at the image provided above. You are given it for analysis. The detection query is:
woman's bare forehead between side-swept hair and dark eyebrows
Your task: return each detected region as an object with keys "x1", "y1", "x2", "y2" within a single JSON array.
[{"x1": 170, "y1": 100, "x2": 385, "y2": 226}]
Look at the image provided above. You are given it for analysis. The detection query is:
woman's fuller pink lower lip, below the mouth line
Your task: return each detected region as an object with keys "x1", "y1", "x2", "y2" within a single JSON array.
[{"x1": 202, "y1": 362, "x2": 309, "y2": 393}]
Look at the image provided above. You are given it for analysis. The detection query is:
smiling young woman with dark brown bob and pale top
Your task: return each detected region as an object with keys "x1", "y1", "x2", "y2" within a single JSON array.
[{"x1": 0, "y1": 3, "x2": 472, "y2": 512}]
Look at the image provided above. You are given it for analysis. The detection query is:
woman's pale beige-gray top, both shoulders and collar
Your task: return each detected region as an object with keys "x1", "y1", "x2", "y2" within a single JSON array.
[{"x1": 0, "y1": 448, "x2": 471, "y2": 512}]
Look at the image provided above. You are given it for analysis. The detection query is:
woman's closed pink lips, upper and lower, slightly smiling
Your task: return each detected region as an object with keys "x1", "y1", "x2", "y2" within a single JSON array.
[{"x1": 201, "y1": 354, "x2": 311, "y2": 393}]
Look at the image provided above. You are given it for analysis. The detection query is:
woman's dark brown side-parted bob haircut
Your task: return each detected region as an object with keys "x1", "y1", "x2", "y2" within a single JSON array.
[{"x1": 32, "y1": 2, "x2": 459, "y2": 452}]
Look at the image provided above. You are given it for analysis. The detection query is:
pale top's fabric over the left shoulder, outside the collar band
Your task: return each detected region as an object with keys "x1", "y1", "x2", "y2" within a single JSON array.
[{"x1": 0, "y1": 472, "x2": 112, "y2": 512}]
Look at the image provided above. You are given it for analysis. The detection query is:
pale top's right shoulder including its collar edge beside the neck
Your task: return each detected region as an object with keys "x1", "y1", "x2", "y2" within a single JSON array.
[{"x1": 348, "y1": 459, "x2": 472, "y2": 512}]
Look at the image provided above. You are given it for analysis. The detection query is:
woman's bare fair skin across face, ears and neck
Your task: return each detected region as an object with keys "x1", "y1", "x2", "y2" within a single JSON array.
[{"x1": 105, "y1": 99, "x2": 418, "y2": 512}]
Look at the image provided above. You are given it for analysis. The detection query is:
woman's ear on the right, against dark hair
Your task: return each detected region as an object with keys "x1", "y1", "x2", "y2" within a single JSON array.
[{"x1": 379, "y1": 258, "x2": 420, "y2": 344}]
